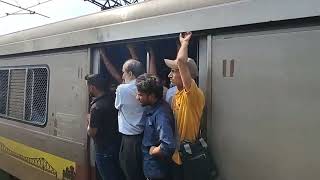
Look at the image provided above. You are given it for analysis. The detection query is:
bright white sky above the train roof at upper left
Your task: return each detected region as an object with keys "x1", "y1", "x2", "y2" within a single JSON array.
[{"x1": 0, "y1": 0, "x2": 100, "y2": 35}]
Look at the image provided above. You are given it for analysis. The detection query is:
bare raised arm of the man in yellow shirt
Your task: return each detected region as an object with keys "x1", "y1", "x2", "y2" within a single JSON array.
[{"x1": 177, "y1": 32, "x2": 192, "y2": 90}]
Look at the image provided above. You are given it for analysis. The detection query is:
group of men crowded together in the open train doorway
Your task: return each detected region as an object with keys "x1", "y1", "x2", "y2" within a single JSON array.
[{"x1": 87, "y1": 32, "x2": 205, "y2": 180}]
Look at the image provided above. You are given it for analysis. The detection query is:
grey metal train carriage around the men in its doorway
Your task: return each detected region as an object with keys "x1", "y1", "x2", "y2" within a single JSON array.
[{"x1": 0, "y1": 0, "x2": 320, "y2": 180}]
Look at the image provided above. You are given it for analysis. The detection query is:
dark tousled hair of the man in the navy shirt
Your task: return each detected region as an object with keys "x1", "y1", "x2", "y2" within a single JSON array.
[{"x1": 136, "y1": 73, "x2": 163, "y2": 99}]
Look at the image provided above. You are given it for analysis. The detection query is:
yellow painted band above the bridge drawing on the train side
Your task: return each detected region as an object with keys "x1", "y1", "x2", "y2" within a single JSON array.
[{"x1": 0, "y1": 136, "x2": 76, "y2": 179}]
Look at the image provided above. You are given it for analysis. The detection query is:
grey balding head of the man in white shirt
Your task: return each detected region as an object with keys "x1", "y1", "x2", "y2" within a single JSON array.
[{"x1": 122, "y1": 59, "x2": 145, "y2": 83}]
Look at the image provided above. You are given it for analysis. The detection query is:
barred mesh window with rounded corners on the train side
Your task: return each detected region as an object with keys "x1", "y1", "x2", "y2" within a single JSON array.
[{"x1": 0, "y1": 67, "x2": 49, "y2": 125}]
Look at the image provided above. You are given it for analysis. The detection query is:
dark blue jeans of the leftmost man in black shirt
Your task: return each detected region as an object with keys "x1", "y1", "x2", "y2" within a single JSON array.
[{"x1": 96, "y1": 147, "x2": 121, "y2": 180}]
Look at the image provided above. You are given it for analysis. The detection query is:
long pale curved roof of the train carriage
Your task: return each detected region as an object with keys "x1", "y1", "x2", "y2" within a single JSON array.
[{"x1": 0, "y1": 0, "x2": 320, "y2": 56}]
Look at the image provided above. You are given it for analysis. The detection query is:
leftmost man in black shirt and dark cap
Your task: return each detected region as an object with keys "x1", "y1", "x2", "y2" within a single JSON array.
[{"x1": 86, "y1": 74, "x2": 120, "y2": 180}]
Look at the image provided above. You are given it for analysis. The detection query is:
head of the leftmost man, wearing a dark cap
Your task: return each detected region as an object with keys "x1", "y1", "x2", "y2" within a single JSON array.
[{"x1": 85, "y1": 74, "x2": 108, "y2": 97}]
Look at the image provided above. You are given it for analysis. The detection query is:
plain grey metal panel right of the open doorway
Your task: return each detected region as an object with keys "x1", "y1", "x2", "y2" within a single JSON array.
[{"x1": 209, "y1": 30, "x2": 320, "y2": 180}]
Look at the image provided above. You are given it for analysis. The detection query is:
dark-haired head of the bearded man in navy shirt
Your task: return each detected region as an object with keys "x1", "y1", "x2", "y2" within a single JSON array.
[{"x1": 136, "y1": 73, "x2": 163, "y2": 106}]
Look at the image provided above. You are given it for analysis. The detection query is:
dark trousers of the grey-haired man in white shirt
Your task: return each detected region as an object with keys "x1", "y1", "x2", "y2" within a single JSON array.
[{"x1": 119, "y1": 135, "x2": 145, "y2": 180}]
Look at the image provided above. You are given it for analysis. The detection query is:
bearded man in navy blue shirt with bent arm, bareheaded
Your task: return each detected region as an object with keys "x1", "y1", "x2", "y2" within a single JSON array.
[{"x1": 136, "y1": 74, "x2": 176, "y2": 180}]
